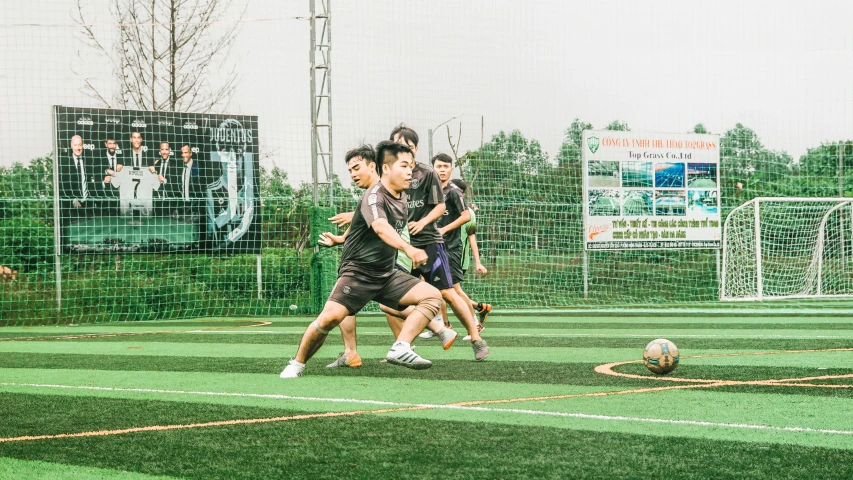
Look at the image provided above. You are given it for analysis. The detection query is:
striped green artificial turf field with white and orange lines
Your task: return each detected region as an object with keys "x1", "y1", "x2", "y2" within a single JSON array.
[{"x1": 0, "y1": 314, "x2": 853, "y2": 478}]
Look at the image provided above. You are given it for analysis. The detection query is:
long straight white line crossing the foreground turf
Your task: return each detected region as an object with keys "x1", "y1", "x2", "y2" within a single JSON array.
[{"x1": 5, "y1": 382, "x2": 853, "y2": 435}]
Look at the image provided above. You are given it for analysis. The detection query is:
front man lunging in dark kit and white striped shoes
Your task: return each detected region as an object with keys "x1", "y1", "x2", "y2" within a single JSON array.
[{"x1": 280, "y1": 142, "x2": 441, "y2": 378}]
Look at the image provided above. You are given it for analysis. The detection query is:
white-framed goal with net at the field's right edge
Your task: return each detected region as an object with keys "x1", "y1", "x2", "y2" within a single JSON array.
[{"x1": 720, "y1": 197, "x2": 853, "y2": 301}]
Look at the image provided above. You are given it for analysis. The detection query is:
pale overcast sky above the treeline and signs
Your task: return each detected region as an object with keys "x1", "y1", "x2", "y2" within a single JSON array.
[{"x1": 0, "y1": 0, "x2": 853, "y2": 186}]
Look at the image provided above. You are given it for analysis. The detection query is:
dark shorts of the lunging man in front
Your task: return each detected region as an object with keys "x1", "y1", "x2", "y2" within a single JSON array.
[{"x1": 329, "y1": 270, "x2": 421, "y2": 315}]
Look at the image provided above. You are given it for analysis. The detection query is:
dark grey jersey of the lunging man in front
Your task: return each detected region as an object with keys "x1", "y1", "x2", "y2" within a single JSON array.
[{"x1": 339, "y1": 183, "x2": 407, "y2": 275}]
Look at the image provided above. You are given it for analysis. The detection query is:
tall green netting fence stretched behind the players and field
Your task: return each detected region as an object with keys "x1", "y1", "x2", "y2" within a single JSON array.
[{"x1": 0, "y1": 0, "x2": 853, "y2": 325}]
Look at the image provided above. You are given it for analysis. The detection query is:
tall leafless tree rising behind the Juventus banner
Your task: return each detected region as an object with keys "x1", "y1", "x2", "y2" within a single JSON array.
[{"x1": 75, "y1": 0, "x2": 245, "y2": 112}]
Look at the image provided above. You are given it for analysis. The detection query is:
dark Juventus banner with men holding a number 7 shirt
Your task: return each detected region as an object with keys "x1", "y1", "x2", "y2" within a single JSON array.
[{"x1": 54, "y1": 106, "x2": 261, "y2": 253}]
